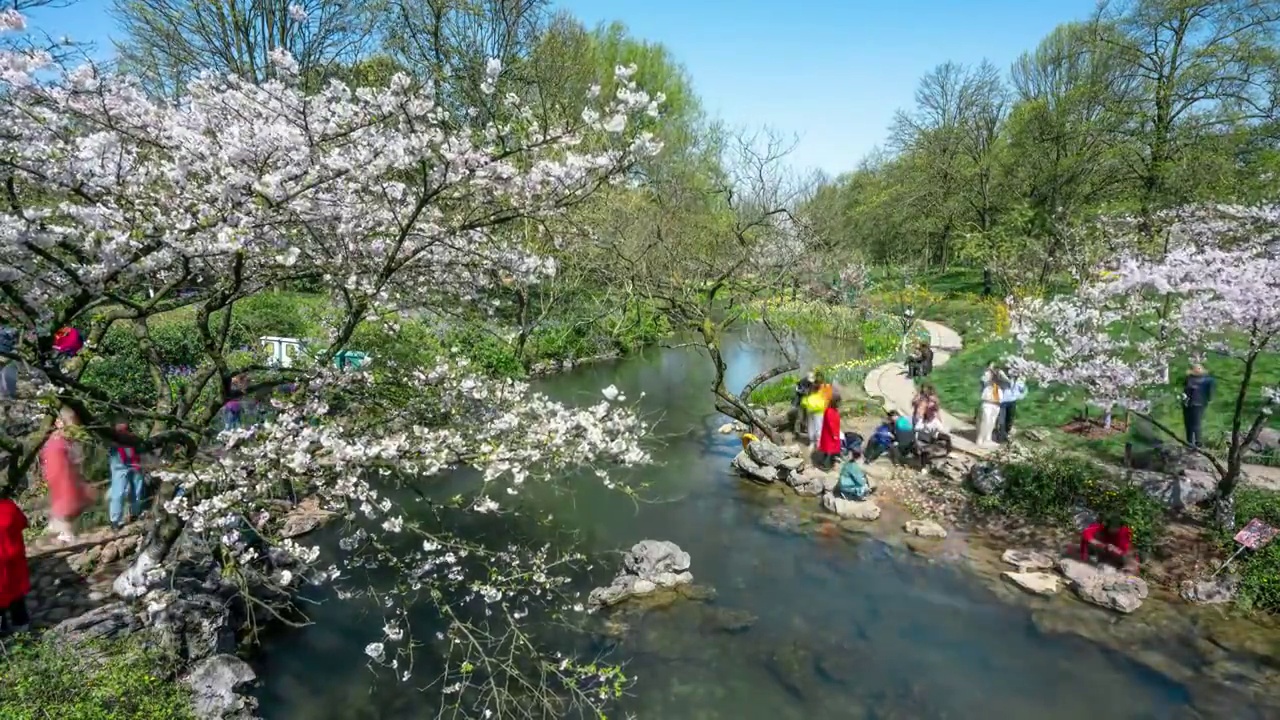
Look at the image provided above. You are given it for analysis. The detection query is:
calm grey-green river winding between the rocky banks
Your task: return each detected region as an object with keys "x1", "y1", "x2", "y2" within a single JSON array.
[{"x1": 249, "y1": 327, "x2": 1259, "y2": 720}]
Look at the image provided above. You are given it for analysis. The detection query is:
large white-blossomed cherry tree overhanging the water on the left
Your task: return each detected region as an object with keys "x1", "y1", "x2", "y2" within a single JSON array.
[{"x1": 0, "y1": 9, "x2": 662, "y2": 717}]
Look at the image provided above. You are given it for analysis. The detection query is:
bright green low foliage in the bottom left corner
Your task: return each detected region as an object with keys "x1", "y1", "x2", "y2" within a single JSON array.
[{"x1": 0, "y1": 639, "x2": 193, "y2": 720}]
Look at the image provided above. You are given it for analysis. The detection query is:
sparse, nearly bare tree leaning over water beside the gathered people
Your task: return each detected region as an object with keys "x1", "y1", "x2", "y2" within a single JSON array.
[{"x1": 590, "y1": 132, "x2": 808, "y2": 439}]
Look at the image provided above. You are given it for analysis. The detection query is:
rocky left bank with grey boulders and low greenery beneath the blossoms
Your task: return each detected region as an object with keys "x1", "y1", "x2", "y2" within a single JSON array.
[{"x1": 0, "y1": 491, "x2": 329, "y2": 720}]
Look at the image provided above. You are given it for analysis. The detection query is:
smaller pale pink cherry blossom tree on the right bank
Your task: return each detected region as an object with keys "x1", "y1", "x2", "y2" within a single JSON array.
[{"x1": 1012, "y1": 205, "x2": 1280, "y2": 525}]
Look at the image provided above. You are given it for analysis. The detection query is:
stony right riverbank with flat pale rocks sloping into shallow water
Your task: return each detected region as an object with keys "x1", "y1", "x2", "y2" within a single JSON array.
[{"x1": 732, "y1": 435, "x2": 1280, "y2": 720}]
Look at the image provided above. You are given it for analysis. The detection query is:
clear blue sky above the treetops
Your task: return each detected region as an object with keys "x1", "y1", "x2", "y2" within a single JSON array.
[{"x1": 24, "y1": 0, "x2": 1094, "y2": 174}]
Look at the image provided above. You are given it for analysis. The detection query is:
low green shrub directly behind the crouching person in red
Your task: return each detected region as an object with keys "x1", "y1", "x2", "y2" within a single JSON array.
[{"x1": 984, "y1": 452, "x2": 1165, "y2": 552}]
